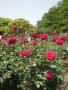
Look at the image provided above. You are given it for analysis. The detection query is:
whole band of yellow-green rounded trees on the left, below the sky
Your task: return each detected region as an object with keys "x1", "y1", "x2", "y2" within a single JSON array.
[{"x1": 0, "y1": 18, "x2": 36, "y2": 34}]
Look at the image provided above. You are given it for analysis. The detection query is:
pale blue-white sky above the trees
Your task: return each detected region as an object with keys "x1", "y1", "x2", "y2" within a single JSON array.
[{"x1": 0, "y1": 0, "x2": 61, "y2": 25}]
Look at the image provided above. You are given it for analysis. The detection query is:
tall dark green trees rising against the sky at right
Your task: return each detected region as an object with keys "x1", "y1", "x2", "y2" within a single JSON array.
[{"x1": 37, "y1": 0, "x2": 68, "y2": 33}]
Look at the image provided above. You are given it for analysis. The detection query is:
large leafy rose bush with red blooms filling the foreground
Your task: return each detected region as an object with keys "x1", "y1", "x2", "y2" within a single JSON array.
[{"x1": 0, "y1": 29, "x2": 66, "y2": 90}]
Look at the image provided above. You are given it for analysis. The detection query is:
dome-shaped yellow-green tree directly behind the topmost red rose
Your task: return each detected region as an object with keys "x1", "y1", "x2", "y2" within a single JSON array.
[{"x1": 8, "y1": 18, "x2": 35, "y2": 33}]
